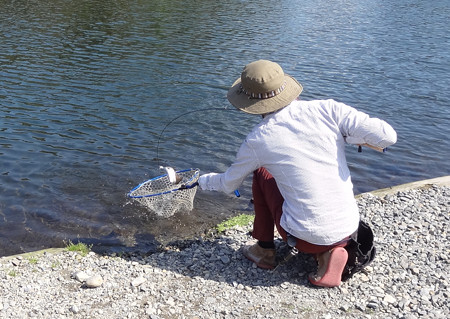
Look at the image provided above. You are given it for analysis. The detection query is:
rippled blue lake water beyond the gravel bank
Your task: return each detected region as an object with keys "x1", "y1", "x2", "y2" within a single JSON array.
[{"x1": 0, "y1": 0, "x2": 450, "y2": 255}]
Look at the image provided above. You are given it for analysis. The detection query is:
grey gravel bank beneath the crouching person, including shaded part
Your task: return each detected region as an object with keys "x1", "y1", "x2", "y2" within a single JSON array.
[{"x1": 0, "y1": 181, "x2": 450, "y2": 319}]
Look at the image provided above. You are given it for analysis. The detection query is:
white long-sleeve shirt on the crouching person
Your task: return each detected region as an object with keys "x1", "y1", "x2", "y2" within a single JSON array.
[{"x1": 199, "y1": 100, "x2": 397, "y2": 245}]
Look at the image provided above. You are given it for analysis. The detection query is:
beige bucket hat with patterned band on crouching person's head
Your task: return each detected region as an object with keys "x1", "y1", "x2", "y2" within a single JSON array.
[{"x1": 227, "y1": 60, "x2": 303, "y2": 114}]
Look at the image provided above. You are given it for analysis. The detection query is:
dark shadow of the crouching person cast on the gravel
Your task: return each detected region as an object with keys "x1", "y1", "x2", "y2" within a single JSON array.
[{"x1": 80, "y1": 230, "x2": 316, "y2": 289}]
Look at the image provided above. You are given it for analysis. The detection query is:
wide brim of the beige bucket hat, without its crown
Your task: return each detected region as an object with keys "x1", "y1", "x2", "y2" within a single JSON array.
[{"x1": 227, "y1": 74, "x2": 303, "y2": 114}]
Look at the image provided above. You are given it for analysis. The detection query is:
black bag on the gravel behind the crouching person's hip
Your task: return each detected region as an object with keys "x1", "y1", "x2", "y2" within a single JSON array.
[{"x1": 342, "y1": 221, "x2": 376, "y2": 281}]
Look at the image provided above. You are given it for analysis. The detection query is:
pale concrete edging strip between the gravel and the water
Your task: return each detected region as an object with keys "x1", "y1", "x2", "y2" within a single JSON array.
[{"x1": 0, "y1": 175, "x2": 450, "y2": 262}]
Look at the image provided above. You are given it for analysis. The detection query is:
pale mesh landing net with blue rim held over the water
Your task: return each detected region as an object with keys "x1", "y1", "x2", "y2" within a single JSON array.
[{"x1": 128, "y1": 168, "x2": 200, "y2": 217}]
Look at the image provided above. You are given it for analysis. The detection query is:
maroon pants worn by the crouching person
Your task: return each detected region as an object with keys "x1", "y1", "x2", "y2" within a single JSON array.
[{"x1": 252, "y1": 167, "x2": 349, "y2": 254}]
